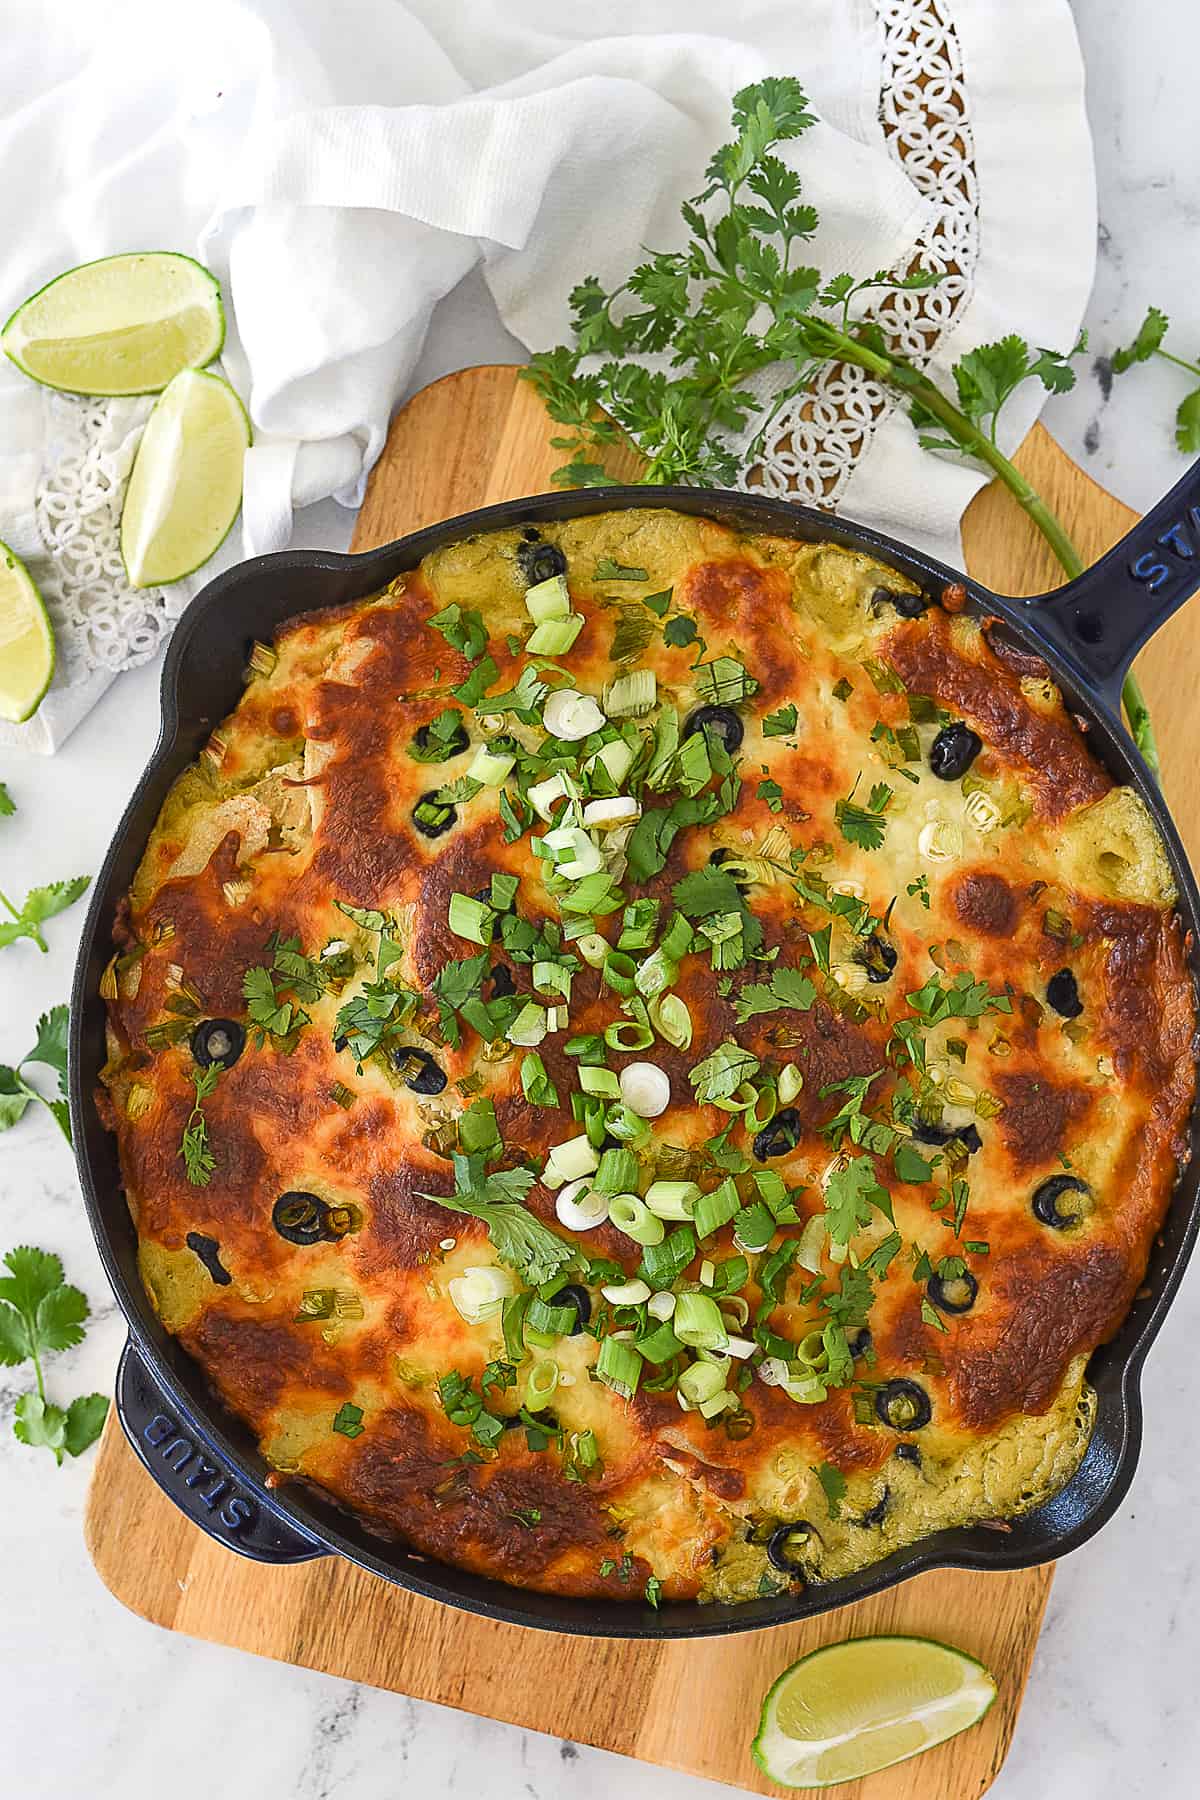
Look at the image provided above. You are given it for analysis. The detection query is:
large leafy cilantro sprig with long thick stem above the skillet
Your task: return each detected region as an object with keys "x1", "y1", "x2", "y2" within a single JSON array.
[{"x1": 524, "y1": 76, "x2": 1165, "y2": 772}]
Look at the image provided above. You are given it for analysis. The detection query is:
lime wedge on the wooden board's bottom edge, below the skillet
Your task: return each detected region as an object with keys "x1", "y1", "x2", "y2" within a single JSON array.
[{"x1": 750, "y1": 1638, "x2": 997, "y2": 1787}]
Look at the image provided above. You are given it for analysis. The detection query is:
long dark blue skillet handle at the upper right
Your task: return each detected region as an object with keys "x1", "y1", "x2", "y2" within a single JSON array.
[{"x1": 1025, "y1": 463, "x2": 1200, "y2": 718}]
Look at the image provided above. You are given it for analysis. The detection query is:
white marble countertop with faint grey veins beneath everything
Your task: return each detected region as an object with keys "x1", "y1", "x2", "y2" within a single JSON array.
[{"x1": 0, "y1": 0, "x2": 1200, "y2": 1800}]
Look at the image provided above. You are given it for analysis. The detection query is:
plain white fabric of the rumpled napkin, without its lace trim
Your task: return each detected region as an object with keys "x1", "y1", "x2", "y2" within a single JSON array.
[{"x1": 0, "y1": 0, "x2": 1094, "y2": 747}]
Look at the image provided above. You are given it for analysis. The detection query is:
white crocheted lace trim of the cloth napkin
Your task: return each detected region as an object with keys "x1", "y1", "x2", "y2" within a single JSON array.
[{"x1": 36, "y1": 0, "x2": 979, "y2": 682}]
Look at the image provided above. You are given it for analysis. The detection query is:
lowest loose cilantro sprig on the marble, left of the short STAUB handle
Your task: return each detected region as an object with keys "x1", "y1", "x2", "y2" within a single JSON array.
[{"x1": 0, "y1": 1244, "x2": 108, "y2": 1467}]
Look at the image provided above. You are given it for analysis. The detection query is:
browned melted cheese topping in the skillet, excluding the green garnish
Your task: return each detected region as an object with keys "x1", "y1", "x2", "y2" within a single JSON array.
[{"x1": 101, "y1": 511, "x2": 1195, "y2": 1598}]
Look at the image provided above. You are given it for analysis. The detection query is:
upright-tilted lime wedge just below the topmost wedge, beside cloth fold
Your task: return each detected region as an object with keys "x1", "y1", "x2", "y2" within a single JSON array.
[{"x1": 121, "y1": 369, "x2": 250, "y2": 587}]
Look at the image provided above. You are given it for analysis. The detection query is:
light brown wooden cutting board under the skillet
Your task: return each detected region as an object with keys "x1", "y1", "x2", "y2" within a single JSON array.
[{"x1": 85, "y1": 367, "x2": 1200, "y2": 1800}]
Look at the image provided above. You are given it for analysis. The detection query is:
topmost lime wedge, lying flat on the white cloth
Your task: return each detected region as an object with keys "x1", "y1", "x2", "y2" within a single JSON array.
[{"x1": 0, "y1": 250, "x2": 225, "y2": 394}]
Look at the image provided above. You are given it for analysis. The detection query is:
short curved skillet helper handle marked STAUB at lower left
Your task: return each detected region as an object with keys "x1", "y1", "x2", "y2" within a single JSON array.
[{"x1": 117, "y1": 1339, "x2": 329, "y2": 1562}]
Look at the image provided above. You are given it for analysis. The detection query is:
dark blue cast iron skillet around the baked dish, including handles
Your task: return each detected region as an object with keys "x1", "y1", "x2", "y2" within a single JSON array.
[{"x1": 70, "y1": 463, "x2": 1200, "y2": 1638}]
